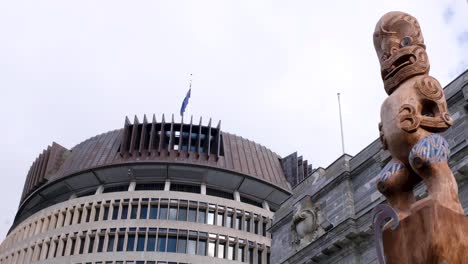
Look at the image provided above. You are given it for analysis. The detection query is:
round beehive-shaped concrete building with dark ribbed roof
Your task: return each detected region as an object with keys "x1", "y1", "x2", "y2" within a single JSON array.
[{"x1": 0, "y1": 116, "x2": 291, "y2": 264}]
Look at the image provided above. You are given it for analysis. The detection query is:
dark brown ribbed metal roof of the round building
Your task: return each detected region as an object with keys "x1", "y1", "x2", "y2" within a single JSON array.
[{"x1": 21, "y1": 116, "x2": 290, "y2": 202}]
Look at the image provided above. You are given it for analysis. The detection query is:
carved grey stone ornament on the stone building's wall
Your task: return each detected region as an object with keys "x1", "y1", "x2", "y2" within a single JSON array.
[{"x1": 291, "y1": 195, "x2": 333, "y2": 250}]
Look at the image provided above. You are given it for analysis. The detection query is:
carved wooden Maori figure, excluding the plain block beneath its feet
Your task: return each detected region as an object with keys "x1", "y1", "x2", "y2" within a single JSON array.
[{"x1": 374, "y1": 12, "x2": 463, "y2": 218}]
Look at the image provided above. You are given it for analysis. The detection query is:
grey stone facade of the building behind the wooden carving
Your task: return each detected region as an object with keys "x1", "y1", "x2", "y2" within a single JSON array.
[{"x1": 271, "y1": 71, "x2": 468, "y2": 264}]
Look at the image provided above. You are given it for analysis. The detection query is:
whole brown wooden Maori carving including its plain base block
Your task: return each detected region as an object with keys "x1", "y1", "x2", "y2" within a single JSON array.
[{"x1": 373, "y1": 12, "x2": 468, "y2": 264}]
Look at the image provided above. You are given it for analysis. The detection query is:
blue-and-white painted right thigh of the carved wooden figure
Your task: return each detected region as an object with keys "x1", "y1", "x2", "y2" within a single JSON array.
[{"x1": 409, "y1": 134, "x2": 450, "y2": 167}]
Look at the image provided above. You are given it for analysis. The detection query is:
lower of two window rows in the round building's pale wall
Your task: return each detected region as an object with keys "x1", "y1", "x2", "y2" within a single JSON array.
[{"x1": 0, "y1": 227, "x2": 270, "y2": 264}]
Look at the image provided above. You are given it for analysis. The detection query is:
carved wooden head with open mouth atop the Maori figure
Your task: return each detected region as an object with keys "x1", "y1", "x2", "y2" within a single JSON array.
[{"x1": 374, "y1": 12, "x2": 429, "y2": 95}]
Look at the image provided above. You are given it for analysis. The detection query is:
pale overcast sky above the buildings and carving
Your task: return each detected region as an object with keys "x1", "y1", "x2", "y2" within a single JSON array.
[{"x1": 0, "y1": 0, "x2": 468, "y2": 239}]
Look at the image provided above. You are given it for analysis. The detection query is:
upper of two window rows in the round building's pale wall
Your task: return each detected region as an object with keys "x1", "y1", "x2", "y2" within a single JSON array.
[{"x1": 2, "y1": 198, "x2": 270, "y2": 254}]
